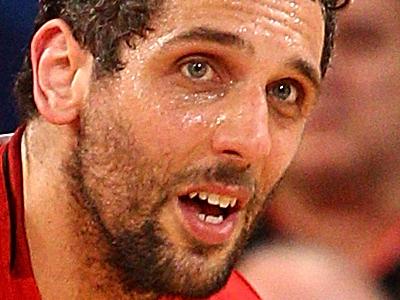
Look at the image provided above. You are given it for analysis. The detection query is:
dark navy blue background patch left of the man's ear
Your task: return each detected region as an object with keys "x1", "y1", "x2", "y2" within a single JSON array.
[{"x1": 0, "y1": 0, "x2": 38, "y2": 134}]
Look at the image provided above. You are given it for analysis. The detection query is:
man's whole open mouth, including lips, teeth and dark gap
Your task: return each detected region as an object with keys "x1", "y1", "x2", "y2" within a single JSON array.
[{"x1": 178, "y1": 191, "x2": 243, "y2": 245}]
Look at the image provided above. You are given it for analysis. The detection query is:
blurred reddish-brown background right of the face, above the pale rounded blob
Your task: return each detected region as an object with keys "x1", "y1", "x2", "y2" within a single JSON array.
[{"x1": 244, "y1": 0, "x2": 400, "y2": 299}]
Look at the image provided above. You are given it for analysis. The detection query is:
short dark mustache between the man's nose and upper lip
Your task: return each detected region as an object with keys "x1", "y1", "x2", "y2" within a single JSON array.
[{"x1": 172, "y1": 163, "x2": 256, "y2": 190}]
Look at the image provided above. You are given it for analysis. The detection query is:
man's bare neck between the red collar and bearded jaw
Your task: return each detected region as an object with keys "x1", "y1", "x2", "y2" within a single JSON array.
[{"x1": 22, "y1": 121, "x2": 155, "y2": 299}]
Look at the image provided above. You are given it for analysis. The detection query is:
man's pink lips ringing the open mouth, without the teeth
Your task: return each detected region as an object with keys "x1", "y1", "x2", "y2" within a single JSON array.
[{"x1": 175, "y1": 184, "x2": 250, "y2": 245}]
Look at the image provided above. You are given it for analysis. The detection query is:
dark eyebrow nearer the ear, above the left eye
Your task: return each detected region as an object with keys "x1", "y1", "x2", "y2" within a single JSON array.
[{"x1": 166, "y1": 27, "x2": 255, "y2": 53}]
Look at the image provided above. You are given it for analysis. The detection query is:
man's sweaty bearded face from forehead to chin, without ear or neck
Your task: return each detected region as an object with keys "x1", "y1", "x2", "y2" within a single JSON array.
[{"x1": 71, "y1": 0, "x2": 324, "y2": 296}]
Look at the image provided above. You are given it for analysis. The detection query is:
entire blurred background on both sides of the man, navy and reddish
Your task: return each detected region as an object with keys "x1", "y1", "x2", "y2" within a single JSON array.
[{"x1": 0, "y1": 0, "x2": 400, "y2": 300}]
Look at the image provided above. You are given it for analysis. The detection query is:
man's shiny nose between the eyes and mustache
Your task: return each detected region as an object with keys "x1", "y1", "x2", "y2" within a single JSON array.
[{"x1": 212, "y1": 84, "x2": 271, "y2": 165}]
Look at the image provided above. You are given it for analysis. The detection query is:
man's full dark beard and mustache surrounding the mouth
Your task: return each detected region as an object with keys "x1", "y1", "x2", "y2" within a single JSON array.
[{"x1": 68, "y1": 108, "x2": 276, "y2": 297}]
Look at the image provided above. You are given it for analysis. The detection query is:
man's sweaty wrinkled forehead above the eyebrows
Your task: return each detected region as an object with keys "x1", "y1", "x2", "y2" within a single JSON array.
[{"x1": 155, "y1": 0, "x2": 324, "y2": 65}]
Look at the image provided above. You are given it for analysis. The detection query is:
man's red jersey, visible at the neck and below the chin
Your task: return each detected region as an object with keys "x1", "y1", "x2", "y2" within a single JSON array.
[{"x1": 0, "y1": 128, "x2": 261, "y2": 300}]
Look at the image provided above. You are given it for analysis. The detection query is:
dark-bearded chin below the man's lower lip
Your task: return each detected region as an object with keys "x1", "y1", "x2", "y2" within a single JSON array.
[{"x1": 107, "y1": 219, "x2": 244, "y2": 298}]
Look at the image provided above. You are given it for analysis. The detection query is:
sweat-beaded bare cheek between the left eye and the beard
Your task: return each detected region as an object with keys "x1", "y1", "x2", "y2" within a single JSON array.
[{"x1": 107, "y1": 71, "x2": 222, "y2": 159}]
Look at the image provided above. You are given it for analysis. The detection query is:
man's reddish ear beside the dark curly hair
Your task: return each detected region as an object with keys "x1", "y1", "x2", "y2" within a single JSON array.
[{"x1": 31, "y1": 19, "x2": 93, "y2": 125}]
